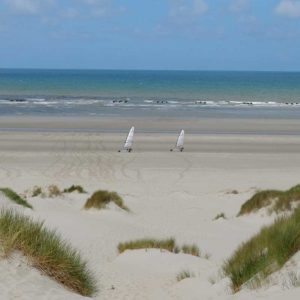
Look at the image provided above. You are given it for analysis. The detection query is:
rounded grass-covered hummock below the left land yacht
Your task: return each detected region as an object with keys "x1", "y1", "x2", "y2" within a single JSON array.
[{"x1": 84, "y1": 190, "x2": 129, "y2": 211}]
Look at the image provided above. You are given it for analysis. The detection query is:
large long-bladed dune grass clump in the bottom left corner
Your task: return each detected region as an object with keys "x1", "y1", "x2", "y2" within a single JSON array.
[{"x1": 0, "y1": 210, "x2": 96, "y2": 296}]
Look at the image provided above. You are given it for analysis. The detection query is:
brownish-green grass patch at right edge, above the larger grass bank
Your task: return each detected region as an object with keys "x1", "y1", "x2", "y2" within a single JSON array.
[{"x1": 238, "y1": 185, "x2": 300, "y2": 216}]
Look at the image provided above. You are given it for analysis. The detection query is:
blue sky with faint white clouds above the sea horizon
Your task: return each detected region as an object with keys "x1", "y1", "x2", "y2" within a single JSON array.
[{"x1": 0, "y1": 0, "x2": 300, "y2": 71}]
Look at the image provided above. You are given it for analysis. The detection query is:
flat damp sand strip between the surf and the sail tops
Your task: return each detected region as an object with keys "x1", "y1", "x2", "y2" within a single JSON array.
[{"x1": 0, "y1": 116, "x2": 300, "y2": 136}]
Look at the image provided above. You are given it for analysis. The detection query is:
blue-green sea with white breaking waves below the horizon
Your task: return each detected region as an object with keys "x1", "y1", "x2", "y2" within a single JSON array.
[{"x1": 0, "y1": 69, "x2": 300, "y2": 119}]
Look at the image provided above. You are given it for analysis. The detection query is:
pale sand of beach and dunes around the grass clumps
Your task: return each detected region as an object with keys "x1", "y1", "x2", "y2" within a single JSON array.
[{"x1": 0, "y1": 116, "x2": 300, "y2": 300}]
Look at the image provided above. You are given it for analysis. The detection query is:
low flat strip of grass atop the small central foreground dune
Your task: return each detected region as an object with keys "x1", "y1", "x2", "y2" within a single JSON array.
[{"x1": 118, "y1": 238, "x2": 175, "y2": 253}]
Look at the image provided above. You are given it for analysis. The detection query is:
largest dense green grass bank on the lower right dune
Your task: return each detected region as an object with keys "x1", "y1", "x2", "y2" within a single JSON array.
[{"x1": 223, "y1": 206, "x2": 300, "y2": 291}]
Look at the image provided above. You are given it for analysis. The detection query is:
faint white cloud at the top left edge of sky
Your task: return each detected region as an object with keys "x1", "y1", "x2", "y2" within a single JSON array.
[{"x1": 6, "y1": 0, "x2": 53, "y2": 15}]
